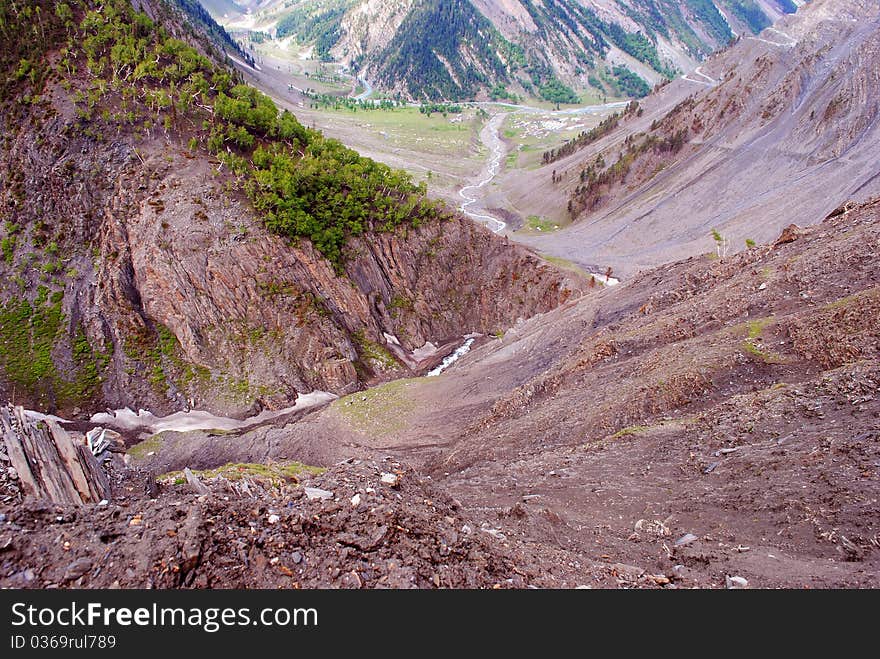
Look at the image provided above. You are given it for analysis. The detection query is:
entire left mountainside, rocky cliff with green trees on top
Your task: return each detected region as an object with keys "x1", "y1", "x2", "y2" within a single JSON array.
[{"x1": 0, "y1": 0, "x2": 580, "y2": 413}]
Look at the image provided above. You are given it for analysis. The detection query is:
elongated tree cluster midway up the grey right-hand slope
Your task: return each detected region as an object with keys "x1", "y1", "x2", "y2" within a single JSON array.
[{"x1": 568, "y1": 128, "x2": 688, "y2": 218}]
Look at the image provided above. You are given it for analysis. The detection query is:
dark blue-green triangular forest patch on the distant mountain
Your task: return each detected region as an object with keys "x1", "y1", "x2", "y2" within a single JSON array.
[{"x1": 376, "y1": 0, "x2": 519, "y2": 101}]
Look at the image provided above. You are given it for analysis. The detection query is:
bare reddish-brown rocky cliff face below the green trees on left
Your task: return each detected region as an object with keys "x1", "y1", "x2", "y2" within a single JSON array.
[{"x1": 0, "y1": 0, "x2": 580, "y2": 413}]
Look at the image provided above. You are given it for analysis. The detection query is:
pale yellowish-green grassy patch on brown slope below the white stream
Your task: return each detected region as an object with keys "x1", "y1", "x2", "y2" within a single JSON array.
[{"x1": 330, "y1": 379, "x2": 419, "y2": 437}]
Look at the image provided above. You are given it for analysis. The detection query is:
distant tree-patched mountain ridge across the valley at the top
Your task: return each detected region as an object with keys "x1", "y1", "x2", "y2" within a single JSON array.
[{"x1": 204, "y1": 0, "x2": 803, "y2": 101}]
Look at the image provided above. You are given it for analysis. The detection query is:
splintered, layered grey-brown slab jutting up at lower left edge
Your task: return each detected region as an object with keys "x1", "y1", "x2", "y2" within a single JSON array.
[{"x1": 0, "y1": 405, "x2": 110, "y2": 504}]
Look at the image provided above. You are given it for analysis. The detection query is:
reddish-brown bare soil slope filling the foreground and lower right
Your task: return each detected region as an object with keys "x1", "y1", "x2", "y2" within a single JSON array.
[{"x1": 0, "y1": 202, "x2": 880, "y2": 588}]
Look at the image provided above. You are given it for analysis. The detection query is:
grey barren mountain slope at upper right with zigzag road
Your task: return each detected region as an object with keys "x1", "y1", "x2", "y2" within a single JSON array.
[{"x1": 505, "y1": 0, "x2": 880, "y2": 274}]
